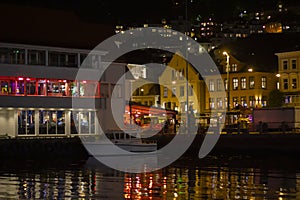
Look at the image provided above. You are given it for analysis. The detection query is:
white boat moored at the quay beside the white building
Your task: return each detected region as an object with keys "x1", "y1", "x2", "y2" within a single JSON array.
[{"x1": 81, "y1": 131, "x2": 157, "y2": 156}]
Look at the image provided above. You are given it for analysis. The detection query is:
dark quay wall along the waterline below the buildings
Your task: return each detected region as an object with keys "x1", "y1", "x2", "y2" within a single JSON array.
[{"x1": 0, "y1": 133, "x2": 300, "y2": 160}]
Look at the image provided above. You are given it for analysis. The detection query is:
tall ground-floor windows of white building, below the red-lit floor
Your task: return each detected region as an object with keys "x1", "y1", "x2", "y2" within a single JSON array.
[{"x1": 17, "y1": 110, "x2": 96, "y2": 135}]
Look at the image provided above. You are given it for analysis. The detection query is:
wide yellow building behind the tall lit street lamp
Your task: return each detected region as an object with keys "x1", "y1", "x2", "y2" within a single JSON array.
[{"x1": 205, "y1": 55, "x2": 277, "y2": 112}]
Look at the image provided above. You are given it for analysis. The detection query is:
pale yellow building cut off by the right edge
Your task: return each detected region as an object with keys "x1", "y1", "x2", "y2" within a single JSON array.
[{"x1": 275, "y1": 50, "x2": 300, "y2": 106}]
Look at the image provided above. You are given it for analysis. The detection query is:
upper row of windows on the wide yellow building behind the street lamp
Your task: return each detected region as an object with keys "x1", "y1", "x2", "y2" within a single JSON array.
[{"x1": 209, "y1": 76, "x2": 267, "y2": 92}]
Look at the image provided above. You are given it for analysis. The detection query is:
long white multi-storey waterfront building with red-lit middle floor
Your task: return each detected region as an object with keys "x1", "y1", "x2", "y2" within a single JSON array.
[{"x1": 0, "y1": 43, "x2": 126, "y2": 137}]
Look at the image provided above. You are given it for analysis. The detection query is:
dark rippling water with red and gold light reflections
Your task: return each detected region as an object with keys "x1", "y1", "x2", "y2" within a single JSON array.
[{"x1": 0, "y1": 156, "x2": 300, "y2": 200}]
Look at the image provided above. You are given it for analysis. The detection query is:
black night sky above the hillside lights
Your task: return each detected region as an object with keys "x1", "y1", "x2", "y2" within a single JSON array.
[{"x1": 1, "y1": 0, "x2": 299, "y2": 24}]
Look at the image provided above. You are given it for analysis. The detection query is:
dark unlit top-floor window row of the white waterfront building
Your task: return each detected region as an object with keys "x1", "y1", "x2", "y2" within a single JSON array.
[{"x1": 0, "y1": 47, "x2": 101, "y2": 68}]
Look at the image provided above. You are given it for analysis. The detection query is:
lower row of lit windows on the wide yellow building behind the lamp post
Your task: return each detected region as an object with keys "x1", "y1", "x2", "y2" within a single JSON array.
[{"x1": 209, "y1": 96, "x2": 267, "y2": 109}]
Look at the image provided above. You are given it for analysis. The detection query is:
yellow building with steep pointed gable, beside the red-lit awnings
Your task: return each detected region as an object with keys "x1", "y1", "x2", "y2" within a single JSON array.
[{"x1": 159, "y1": 54, "x2": 205, "y2": 114}]
